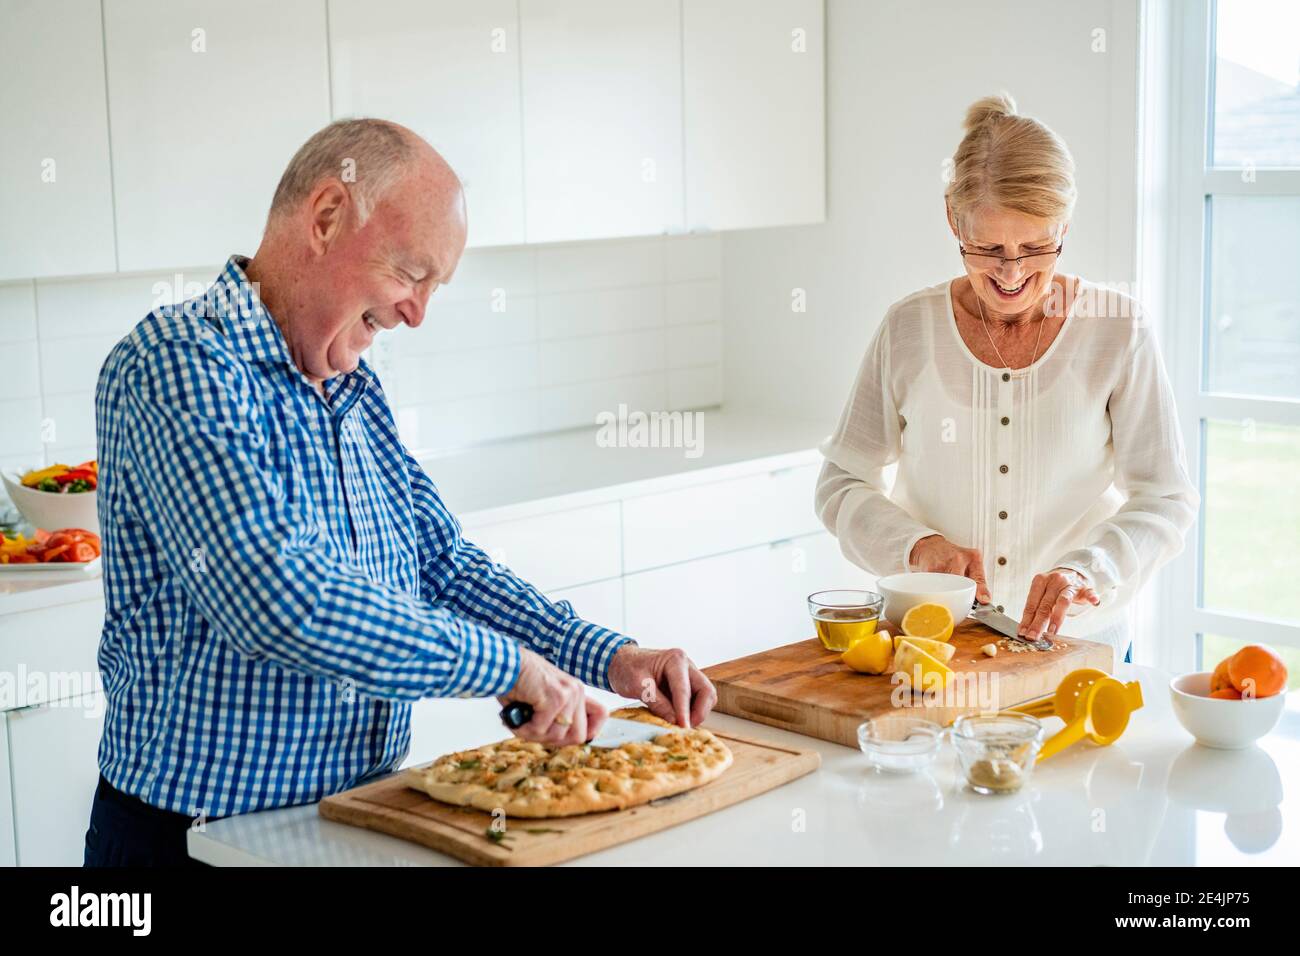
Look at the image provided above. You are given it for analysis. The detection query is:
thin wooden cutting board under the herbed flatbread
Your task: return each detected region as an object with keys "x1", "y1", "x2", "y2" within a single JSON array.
[{"x1": 320, "y1": 728, "x2": 822, "y2": 866}]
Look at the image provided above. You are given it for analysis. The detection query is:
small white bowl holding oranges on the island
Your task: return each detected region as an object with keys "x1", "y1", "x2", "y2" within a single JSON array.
[{"x1": 1169, "y1": 644, "x2": 1287, "y2": 750}]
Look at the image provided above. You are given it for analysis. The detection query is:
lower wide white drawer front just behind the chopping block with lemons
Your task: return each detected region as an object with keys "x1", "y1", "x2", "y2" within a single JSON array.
[{"x1": 624, "y1": 532, "x2": 872, "y2": 667}]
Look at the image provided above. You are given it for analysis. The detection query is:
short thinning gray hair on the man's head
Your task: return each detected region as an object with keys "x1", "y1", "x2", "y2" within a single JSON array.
[{"x1": 270, "y1": 118, "x2": 416, "y2": 225}]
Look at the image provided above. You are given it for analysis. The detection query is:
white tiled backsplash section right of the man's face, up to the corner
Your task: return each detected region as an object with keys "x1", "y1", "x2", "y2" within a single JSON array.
[{"x1": 373, "y1": 237, "x2": 723, "y2": 450}]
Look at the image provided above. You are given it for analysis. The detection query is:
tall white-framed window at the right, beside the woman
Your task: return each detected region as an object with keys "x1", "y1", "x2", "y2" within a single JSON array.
[{"x1": 1144, "y1": 0, "x2": 1300, "y2": 687}]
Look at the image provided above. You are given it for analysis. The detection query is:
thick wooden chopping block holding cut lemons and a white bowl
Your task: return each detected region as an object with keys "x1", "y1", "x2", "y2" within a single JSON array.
[{"x1": 705, "y1": 620, "x2": 1114, "y2": 748}]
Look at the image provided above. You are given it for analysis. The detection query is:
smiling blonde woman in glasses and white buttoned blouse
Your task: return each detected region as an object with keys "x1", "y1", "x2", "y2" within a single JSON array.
[{"x1": 816, "y1": 95, "x2": 1199, "y2": 659}]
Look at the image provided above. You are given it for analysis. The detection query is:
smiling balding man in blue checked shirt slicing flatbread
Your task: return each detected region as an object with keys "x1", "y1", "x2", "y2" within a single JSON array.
[{"x1": 86, "y1": 120, "x2": 716, "y2": 865}]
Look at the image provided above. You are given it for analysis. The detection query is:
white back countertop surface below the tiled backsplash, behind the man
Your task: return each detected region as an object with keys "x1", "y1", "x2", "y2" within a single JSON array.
[{"x1": 0, "y1": 408, "x2": 827, "y2": 615}]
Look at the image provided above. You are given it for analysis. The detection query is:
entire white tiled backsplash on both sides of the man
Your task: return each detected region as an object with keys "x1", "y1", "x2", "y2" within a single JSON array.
[{"x1": 0, "y1": 235, "x2": 723, "y2": 481}]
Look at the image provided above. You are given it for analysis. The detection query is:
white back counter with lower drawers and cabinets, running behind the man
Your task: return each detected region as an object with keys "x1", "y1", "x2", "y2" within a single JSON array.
[{"x1": 0, "y1": 408, "x2": 842, "y2": 866}]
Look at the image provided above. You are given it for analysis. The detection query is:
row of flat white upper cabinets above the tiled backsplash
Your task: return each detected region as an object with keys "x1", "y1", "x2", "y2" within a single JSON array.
[{"x1": 0, "y1": 0, "x2": 826, "y2": 281}]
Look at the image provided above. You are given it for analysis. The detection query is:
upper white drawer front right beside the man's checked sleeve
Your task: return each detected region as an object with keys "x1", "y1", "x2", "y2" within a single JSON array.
[{"x1": 465, "y1": 502, "x2": 623, "y2": 591}]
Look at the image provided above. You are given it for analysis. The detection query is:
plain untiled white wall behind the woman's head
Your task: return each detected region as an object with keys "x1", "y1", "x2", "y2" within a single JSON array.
[{"x1": 723, "y1": 0, "x2": 1139, "y2": 429}]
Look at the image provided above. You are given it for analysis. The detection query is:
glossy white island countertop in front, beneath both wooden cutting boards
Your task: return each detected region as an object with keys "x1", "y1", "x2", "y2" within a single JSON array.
[{"x1": 189, "y1": 665, "x2": 1300, "y2": 866}]
